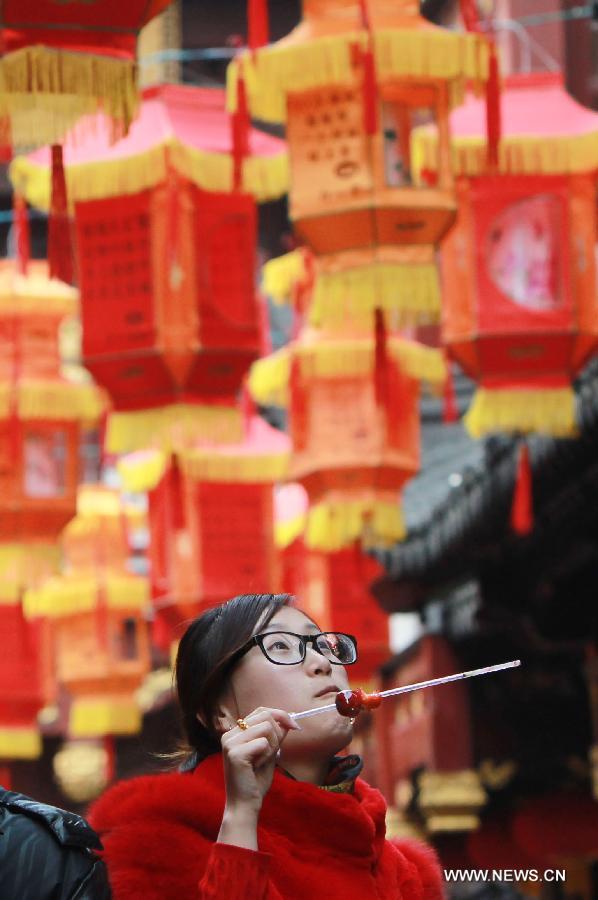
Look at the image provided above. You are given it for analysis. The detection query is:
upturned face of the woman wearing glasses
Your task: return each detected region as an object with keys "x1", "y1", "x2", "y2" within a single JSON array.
[{"x1": 221, "y1": 606, "x2": 352, "y2": 759}]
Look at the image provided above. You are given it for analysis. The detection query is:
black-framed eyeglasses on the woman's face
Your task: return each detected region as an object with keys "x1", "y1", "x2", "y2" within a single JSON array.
[{"x1": 230, "y1": 631, "x2": 357, "y2": 666}]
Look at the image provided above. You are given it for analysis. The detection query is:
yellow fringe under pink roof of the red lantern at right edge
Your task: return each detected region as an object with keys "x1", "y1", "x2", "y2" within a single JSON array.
[{"x1": 411, "y1": 128, "x2": 598, "y2": 180}]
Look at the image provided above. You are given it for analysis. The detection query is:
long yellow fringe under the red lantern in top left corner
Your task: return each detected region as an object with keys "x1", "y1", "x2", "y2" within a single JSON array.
[{"x1": 0, "y1": 45, "x2": 139, "y2": 149}]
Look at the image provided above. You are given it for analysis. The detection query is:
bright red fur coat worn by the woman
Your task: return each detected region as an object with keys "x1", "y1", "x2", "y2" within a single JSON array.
[{"x1": 90, "y1": 754, "x2": 443, "y2": 900}]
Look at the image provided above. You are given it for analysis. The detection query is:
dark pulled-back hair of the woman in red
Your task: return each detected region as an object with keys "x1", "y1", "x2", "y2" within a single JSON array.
[{"x1": 175, "y1": 594, "x2": 294, "y2": 769}]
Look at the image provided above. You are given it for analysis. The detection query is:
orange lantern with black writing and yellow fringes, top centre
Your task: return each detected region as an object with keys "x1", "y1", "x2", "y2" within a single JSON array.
[{"x1": 229, "y1": 0, "x2": 487, "y2": 328}]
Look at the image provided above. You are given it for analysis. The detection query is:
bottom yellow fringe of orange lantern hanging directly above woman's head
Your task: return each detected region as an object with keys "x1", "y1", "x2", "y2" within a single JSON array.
[{"x1": 305, "y1": 500, "x2": 406, "y2": 553}]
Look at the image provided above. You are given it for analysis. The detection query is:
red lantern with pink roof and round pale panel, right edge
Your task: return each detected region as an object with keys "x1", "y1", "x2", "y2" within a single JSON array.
[{"x1": 418, "y1": 74, "x2": 598, "y2": 436}]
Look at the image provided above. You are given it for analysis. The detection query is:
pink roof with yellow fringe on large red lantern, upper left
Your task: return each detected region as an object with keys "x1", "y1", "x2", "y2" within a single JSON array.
[{"x1": 10, "y1": 84, "x2": 288, "y2": 209}]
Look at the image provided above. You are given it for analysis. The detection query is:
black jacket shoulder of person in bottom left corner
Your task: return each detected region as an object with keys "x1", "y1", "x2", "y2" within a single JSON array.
[{"x1": 0, "y1": 787, "x2": 110, "y2": 900}]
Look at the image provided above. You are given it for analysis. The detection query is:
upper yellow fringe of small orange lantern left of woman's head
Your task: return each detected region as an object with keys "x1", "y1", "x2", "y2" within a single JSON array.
[{"x1": 23, "y1": 573, "x2": 150, "y2": 619}]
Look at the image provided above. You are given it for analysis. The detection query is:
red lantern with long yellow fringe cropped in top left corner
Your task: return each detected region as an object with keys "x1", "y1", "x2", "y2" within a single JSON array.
[{"x1": 0, "y1": 0, "x2": 178, "y2": 147}]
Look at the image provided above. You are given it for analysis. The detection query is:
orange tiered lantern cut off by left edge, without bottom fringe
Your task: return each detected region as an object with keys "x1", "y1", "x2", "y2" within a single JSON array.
[{"x1": 0, "y1": 263, "x2": 102, "y2": 540}]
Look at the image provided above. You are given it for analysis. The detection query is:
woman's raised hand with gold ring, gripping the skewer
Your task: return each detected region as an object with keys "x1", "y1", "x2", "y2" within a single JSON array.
[{"x1": 222, "y1": 706, "x2": 301, "y2": 816}]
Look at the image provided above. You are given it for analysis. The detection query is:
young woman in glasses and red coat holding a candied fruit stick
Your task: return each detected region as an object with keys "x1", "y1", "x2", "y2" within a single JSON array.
[{"x1": 90, "y1": 594, "x2": 443, "y2": 900}]
